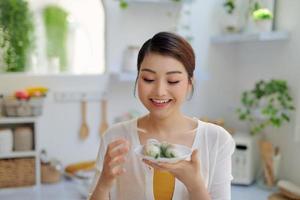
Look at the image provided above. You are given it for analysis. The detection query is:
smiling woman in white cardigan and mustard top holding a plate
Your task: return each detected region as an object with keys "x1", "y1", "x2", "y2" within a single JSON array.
[{"x1": 89, "y1": 32, "x2": 235, "y2": 200}]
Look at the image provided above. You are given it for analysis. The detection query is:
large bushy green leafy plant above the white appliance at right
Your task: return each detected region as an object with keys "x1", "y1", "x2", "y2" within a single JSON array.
[{"x1": 237, "y1": 79, "x2": 295, "y2": 135}]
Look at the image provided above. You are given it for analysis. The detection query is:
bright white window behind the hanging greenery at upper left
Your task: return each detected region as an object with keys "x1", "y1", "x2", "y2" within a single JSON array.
[{"x1": 29, "y1": 0, "x2": 105, "y2": 74}]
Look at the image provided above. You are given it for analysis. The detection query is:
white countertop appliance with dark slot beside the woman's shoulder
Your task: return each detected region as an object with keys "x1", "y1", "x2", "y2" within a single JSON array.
[{"x1": 232, "y1": 133, "x2": 259, "y2": 185}]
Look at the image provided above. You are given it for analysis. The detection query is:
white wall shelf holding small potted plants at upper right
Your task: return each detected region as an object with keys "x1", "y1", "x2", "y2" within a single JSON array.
[{"x1": 211, "y1": 31, "x2": 289, "y2": 44}]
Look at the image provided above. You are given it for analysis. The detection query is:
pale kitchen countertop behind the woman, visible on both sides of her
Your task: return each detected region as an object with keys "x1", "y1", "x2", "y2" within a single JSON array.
[{"x1": 0, "y1": 180, "x2": 270, "y2": 200}]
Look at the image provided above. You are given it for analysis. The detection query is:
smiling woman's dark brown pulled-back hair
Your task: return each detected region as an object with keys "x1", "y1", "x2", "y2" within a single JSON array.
[{"x1": 134, "y1": 32, "x2": 195, "y2": 99}]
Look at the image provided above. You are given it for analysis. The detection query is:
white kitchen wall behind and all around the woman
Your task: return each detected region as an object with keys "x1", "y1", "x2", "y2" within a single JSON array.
[{"x1": 0, "y1": 0, "x2": 300, "y2": 198}]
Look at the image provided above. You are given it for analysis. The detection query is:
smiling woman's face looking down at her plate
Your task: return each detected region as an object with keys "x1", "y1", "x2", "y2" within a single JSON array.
[{"x1": 137, "y1": 53, "x2": 191, "y2": 118}]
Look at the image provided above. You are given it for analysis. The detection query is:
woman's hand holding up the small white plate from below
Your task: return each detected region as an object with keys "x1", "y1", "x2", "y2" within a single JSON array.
[{"x1": 143, "y1": 149, "x2": 203, "y2": 191}]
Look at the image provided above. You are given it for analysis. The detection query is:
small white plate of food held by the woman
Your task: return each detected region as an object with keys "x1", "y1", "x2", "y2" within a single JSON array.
[{"x1": 134, "y1": 144, "x2": 192, "y2": 163}]
